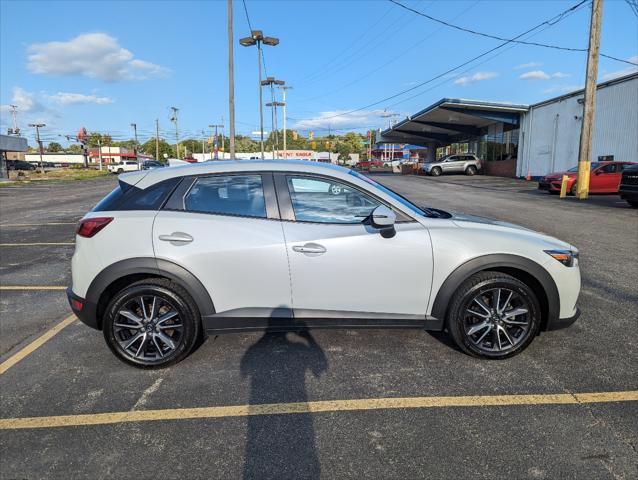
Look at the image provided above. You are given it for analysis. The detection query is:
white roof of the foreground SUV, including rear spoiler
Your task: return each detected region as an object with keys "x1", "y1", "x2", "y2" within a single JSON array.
[{"x1": 125, "y1": 160, "x2": 351, "y2": 189}]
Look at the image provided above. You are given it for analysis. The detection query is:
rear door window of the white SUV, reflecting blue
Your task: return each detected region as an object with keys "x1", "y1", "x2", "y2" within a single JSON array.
[{"x1": 184, "y1": 175, "x2": 266, "y2": 218}]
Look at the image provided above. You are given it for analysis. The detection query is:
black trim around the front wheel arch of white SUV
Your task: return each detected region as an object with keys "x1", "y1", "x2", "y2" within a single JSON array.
[{"x1": 432, "y1": 254, "x2": 560, "y2": 330}]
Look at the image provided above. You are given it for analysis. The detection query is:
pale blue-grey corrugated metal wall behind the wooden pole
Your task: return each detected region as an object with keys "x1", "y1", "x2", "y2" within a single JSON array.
[{"x1": 516, "y1": 72, "x2": 638, "y2": 176}]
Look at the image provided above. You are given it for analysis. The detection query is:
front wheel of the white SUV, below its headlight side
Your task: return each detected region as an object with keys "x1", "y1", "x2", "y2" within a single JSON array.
[{"x1": 446, "y1": 272, "x2": 541, "y2": 360}]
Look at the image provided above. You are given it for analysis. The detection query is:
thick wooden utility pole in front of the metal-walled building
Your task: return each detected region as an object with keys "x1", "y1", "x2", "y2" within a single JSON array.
[{"x1": 576, "y1": 0, "x2": 603, "y2": 200}]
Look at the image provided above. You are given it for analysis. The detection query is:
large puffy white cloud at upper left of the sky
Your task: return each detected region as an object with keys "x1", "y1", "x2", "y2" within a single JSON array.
[{"x1": 27, "y1": 33, "x2": 169, "y2": 82}]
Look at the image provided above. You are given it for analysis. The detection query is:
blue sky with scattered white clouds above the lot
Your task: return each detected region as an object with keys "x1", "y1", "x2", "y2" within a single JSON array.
[{"x1": 0, "y1": 0, "x2": 638, "y2": 145}]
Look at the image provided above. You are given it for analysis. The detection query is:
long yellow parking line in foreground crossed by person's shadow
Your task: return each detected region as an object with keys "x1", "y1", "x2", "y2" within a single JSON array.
[{"x1": 0, "y1": 390, "x2": 638, "y2": 430}]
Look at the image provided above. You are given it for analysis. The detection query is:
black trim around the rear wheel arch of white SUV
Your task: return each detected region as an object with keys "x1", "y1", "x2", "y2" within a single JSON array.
[{"x1": 83, "y1": 257, "x2": 215, "y2": 329}]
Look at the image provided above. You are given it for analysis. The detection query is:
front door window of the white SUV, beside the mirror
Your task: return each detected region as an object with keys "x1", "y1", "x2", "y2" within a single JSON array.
[{"x1": 288, "y1": 177, "x2": 381, "y2": 224}]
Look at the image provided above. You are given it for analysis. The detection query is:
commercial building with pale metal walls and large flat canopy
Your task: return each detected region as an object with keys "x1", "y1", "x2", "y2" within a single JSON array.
[{"x1": 377, "y1": 73, "x2": 638, "y2": 177}]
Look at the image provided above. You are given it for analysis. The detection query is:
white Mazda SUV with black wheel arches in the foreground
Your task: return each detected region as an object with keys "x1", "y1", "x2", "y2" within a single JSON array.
[{"x1": 68, "y1": 161, "x2": 580, "y2": 367}]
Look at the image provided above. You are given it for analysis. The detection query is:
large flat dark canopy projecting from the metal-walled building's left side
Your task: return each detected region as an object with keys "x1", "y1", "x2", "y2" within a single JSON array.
[{"x1": 377, "y1": 98, "x2": 528, "y2": 146}]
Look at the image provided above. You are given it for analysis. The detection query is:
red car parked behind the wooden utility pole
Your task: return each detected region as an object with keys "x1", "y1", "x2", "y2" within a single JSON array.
[{"x1": 538, "y1": 162, "x2": 636, "y2": 195}]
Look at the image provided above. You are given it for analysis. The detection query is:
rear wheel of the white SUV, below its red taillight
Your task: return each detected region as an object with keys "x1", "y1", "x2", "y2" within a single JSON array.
[{"x1": 102, "y1": 278, "x2": 201, "y2": 368}]
